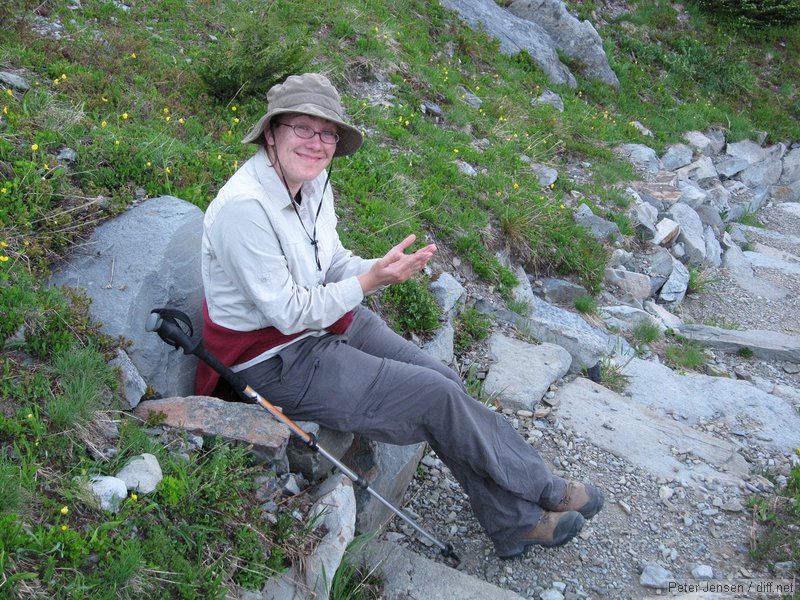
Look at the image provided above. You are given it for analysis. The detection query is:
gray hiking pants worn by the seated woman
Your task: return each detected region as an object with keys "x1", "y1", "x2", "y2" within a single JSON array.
[{"x1": 240, "y1": 307, "x2": 566, "y2": 552}]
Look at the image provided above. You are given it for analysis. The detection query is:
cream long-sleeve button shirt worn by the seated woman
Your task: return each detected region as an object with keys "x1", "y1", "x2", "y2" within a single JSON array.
[{"x1": 202, "y1": 147, "x2": 377, "y2": 370}]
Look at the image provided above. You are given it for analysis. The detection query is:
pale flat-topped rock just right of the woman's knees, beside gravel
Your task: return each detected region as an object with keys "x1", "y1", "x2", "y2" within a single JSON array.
[{"x1": 483, "y1": 334, "x2": 572, "y2": 410}]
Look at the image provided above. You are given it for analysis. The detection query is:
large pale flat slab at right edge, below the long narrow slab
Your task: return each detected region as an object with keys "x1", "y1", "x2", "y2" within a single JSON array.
[{"x1": 623, "y1": 358, "x2": 800, "y2": 453}]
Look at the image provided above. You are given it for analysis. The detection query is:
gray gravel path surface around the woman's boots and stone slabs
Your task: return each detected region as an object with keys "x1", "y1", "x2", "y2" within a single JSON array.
[{"x1": 376, "y1": 200, "x2": 800, "y2": 599}]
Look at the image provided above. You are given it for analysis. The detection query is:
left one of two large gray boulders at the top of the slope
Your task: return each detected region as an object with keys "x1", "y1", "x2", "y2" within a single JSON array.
[{"x1": 440, "y1": 0, "x2": 578, "y2": 88}]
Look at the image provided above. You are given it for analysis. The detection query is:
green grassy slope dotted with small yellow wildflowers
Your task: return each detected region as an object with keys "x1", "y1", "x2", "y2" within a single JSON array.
[{"x1": 0, "y1": 0, "x2": 800, "y2": 598}]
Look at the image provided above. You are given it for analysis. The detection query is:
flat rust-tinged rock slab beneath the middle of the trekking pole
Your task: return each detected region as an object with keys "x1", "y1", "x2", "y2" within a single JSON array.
[{"x1": 132, "y1": 396, "x2": 290, "y2": 462}]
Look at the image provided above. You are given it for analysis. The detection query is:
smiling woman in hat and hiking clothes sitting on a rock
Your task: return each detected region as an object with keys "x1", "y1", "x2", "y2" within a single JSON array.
[{"x1": 196, "y1": 73, "x2": 603, "y2": 558}]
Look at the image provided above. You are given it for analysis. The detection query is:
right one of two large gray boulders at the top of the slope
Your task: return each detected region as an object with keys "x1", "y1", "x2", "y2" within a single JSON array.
[{"x1": 508, "y1": 0, "x2": 619, "y2": 89}]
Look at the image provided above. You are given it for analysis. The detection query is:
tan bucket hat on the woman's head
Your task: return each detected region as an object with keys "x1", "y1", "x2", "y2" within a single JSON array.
[{"x1": 242, "y1": 73, "x2": 364, "y2": 156}]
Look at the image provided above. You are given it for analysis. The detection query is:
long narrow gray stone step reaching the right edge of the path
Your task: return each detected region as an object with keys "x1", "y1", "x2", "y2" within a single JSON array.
[{"x1": 678, "y1": 324, "x2": 800, "y2": 363}]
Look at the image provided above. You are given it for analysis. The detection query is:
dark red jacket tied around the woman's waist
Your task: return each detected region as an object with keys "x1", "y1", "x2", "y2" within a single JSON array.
[{"x1": 194, "y1": 300, "x2": 353, "y2": 396}]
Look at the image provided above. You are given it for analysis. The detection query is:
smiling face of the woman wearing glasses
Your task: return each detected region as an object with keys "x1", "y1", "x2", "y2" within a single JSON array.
[{"x1": 264, "y1": 115, "x2": 337, "y2": 196}]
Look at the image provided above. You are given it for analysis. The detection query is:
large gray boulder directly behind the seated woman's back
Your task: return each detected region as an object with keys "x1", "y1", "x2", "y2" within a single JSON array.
[{"x1": 50, "y1": 196, "x2": 203, "y2": 396}]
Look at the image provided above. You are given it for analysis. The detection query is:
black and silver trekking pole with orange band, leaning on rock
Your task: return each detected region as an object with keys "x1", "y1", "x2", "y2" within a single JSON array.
[{"x1": 145, "y1": 308, "x2": 460, "y2": 562}]
